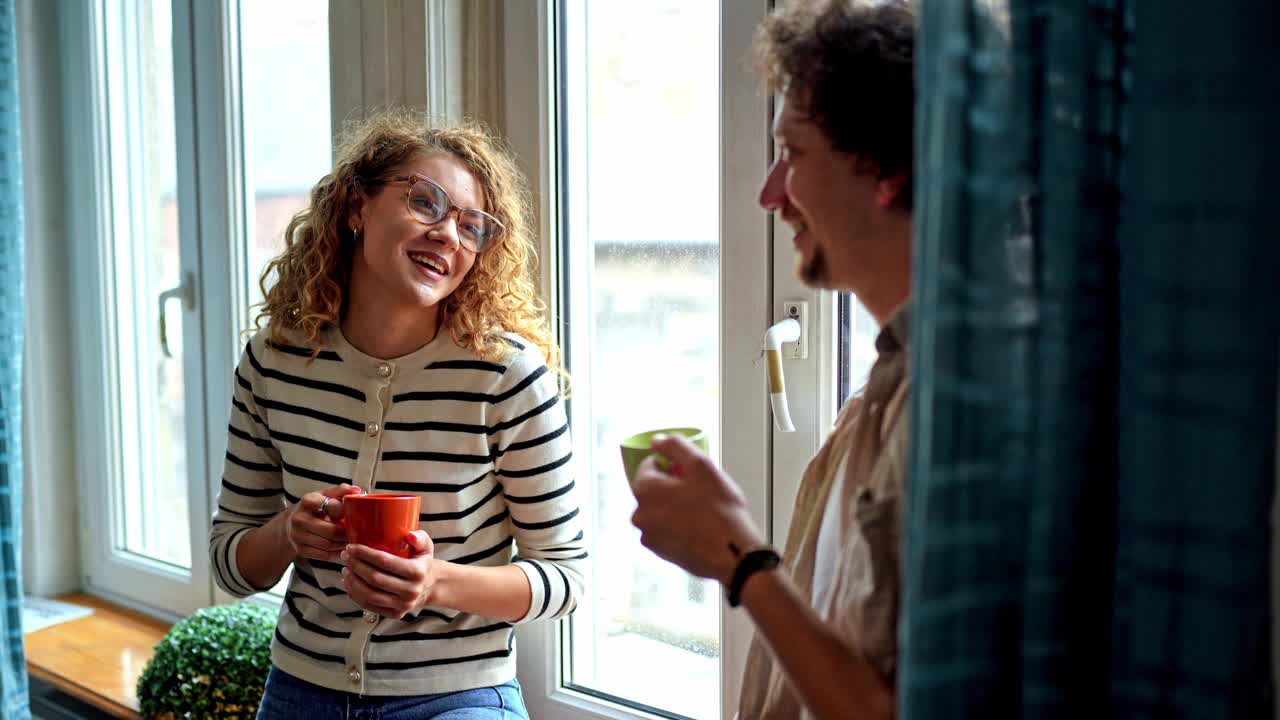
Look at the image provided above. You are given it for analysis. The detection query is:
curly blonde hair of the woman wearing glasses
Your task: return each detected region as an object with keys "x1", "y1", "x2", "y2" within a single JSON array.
[{"x1": 255, "y1": 110, "x2": 567, "y2": 381}]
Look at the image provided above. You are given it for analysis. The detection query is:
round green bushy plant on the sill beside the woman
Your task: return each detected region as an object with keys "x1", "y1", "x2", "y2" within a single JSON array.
[{"x1": 138, "y1": 602, "x2": 275, "y2": 719}]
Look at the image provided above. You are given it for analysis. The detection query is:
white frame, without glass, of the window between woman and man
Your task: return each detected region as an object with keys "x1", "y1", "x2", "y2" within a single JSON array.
[{"x1": 503, "y1": 0, "x2": 838, "y2": 720}]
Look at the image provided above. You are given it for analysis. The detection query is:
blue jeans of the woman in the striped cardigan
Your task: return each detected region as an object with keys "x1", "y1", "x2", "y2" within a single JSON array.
[{"x1": 257, "y1": 666, "x2": 529, "y2": 720}]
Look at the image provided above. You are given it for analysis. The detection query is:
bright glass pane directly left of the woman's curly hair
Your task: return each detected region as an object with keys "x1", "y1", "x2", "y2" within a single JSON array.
[{"x1": 234, "y1": 0, "x2": 333, "y2": 596}]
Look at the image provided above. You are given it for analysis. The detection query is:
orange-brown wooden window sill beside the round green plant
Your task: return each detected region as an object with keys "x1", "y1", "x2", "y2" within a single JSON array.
[{"x1": 26, "y1": 594, "x2": 169, "y2": 717}]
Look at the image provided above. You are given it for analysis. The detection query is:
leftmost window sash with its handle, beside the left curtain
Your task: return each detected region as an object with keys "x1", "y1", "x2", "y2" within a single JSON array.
[{"x1": 68, "y1": 0, "x2": 209, "y2": 612}]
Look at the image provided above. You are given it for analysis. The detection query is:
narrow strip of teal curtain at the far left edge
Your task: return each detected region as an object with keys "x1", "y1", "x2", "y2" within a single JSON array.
[{"x1": 0, "y1": 0, "x2": 29, "y2": 717}]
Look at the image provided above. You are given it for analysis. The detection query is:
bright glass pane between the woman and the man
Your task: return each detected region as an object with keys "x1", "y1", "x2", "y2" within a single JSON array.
[{"x1": 562, "y1": 0, "x2": 721, "y2": 719}]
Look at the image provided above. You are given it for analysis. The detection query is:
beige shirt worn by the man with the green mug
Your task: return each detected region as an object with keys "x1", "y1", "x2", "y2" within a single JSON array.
[{"x1": 739, "y1": 305, "x2": 910, "y2": 720}]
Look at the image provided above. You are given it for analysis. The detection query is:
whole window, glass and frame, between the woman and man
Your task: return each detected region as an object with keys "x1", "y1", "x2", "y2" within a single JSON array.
[{"x1": 506, "y1": 0, "x2": 837, "y2": 719}]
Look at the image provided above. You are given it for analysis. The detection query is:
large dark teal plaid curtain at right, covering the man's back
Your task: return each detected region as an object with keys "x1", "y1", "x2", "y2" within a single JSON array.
[{"x1": 899, "y1": 0, "x2": 1280, "y2": 720}]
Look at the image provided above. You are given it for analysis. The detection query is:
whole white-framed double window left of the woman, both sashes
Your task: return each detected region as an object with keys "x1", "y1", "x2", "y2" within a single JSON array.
[{"x1": 65, "y1": 0, "x2": 332, "y2": 615}]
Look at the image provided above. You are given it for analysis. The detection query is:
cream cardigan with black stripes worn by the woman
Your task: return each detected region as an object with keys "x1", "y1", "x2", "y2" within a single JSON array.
[{"x1": 209, "y1": 328, "x2": 586, "y2": 696}]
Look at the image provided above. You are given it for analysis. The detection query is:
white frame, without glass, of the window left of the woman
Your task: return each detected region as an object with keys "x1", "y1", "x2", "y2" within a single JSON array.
[{"x1": 60, "y1": 0, "x2": 248, "y2": 619}]
